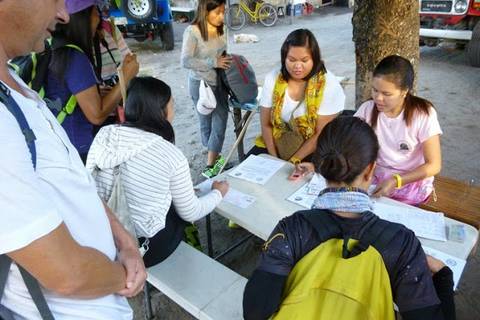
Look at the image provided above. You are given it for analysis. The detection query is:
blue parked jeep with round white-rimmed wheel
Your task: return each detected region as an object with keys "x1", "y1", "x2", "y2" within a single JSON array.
[{"x1": 110, "y1": 0, "x2": 174, "y2": 50}]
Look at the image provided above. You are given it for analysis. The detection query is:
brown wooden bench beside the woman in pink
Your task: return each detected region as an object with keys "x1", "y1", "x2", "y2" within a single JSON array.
[{"x1": 421, "y1": 176, "x2": 480, "y2": 230}]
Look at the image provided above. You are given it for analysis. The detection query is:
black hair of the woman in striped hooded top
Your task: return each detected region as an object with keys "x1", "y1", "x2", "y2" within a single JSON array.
[{"x1": 124, "y1": 77, "x2": 175, "y2": 143}]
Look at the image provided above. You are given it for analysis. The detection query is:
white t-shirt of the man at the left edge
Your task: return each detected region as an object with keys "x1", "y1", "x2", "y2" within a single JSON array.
[{"x1": 0, "y1": 72, "x2": 133, "y2": 320}]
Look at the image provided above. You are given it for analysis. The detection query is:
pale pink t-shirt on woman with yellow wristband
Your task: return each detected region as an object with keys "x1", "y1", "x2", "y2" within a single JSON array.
[{"x1": 355, "y1": 100, "x2": 442, "y2": 174}]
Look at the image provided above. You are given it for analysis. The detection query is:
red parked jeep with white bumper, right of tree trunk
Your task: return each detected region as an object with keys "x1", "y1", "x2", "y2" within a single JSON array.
[{"x1": 419, "y1": 0, "x2": 480, "y2": 67}]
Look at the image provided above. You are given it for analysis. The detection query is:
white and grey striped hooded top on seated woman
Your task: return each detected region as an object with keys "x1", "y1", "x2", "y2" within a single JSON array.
[{"x1": 87, "y1": 125, "x2": 222, "y2": 238}]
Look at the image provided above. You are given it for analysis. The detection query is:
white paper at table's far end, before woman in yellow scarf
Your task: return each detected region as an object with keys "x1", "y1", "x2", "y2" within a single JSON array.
[{"x1": 228, "y1": 155, "x2": 285, "y2": 185}]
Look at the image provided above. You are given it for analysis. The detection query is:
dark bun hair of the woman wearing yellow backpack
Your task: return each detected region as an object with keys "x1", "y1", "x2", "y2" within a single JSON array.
[{"x1": 312, "y1": 116, "x2": 379, "y2": 184}]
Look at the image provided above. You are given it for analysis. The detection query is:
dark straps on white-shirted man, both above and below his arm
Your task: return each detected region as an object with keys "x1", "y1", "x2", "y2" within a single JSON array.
[{"x1": 0, "y1": 82, "x2": 54, "y2": 320}]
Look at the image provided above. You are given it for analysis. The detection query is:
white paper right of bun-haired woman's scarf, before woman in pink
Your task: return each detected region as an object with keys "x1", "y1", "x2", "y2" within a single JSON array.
[{"x1": 373, "y1": 201, "x2": 447, "y2": 241}]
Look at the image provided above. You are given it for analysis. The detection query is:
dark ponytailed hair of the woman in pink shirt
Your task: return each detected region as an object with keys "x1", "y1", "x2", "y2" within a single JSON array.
[{"x1": 370, "y1": 55, "x2": 433, "y2": 128}]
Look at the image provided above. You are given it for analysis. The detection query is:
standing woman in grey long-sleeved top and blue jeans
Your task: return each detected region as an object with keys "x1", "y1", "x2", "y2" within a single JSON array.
[{"x1": 181, "y1": 0, "x2": 231, "y2": 178}]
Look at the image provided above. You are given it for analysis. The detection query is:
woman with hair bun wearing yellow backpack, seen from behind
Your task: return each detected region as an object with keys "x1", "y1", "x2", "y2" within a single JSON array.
[{"x1": 243, "y1": 117, "x2": 455, "y2": 320}]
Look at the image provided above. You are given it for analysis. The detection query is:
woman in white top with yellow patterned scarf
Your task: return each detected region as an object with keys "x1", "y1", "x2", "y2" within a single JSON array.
[{"x1": 249, "y1": 29, "x2": 345, "y2": 164}]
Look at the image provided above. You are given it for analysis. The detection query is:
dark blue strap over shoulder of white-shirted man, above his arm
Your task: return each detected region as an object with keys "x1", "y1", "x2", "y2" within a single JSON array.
[{"x1": 0, "y1": 82, "x2": 37, "y2": 169}]
